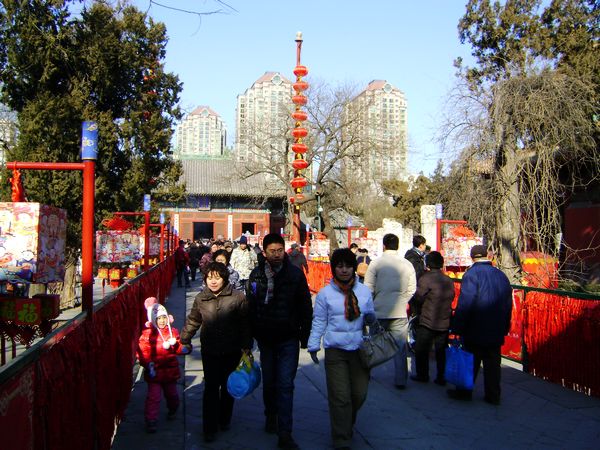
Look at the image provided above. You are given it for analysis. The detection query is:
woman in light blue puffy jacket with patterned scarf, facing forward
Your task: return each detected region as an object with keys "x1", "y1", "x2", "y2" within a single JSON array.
[{"x1": 308, "y1": 248, "x2": 375, "y2": 449}]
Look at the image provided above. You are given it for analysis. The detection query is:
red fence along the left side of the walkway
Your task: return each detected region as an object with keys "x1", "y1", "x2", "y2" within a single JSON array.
[{"x1": 0, "y1": 257, "x2": 175, "y2": 450}]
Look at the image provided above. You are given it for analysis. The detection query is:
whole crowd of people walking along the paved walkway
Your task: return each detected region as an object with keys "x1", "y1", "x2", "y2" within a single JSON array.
[{"x1": 138, "y1": 233, "x2": 512, "y2": 449}]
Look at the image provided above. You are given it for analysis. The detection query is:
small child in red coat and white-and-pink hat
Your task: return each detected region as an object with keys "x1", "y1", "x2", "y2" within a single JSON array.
[{"x1": 137, "y1": 297, "x2": 189, "y2": 433}]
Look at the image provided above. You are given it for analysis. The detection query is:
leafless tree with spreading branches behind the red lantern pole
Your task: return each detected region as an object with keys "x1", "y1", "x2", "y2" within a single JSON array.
[{"x1": 231, "y1": 80, "x2": 389, "y2": 248}]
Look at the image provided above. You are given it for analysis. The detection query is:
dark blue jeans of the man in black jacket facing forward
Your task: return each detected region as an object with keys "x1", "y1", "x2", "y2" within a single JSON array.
[{"x1": 258, "y1": 339, "x2": 300, "y2": 433}]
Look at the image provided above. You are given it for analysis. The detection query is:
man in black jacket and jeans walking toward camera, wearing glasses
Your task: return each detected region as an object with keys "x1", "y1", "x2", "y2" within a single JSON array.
[{"x1": 246, "y1": 233, "x2": 312, "y2": 449}]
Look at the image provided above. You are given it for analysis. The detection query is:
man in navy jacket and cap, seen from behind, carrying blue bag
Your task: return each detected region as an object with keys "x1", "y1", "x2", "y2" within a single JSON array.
[{"x1": 448, "y1": 245, "x2": 512, "y2": 405}]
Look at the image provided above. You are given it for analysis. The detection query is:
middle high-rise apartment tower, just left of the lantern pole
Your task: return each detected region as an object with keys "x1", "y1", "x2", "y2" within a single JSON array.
[{"x1": 235, "y1": 72, "x2": 293, "y2": 162}]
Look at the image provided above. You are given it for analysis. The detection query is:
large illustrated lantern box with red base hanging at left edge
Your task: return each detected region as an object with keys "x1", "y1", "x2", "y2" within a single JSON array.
[{"x1": 0, "y1": 178, "x2": 67, "y2": 348}]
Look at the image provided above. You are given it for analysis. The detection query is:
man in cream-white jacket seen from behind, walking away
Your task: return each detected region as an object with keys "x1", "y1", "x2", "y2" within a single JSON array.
[{"x1": 364, "y1": 234, "x2": 417, "y2": 389}]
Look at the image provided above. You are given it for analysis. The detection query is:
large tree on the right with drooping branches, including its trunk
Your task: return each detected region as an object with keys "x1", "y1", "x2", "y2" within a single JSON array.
[{"x1": 443, "y1": 0, "x2": 600, "y2": 281}]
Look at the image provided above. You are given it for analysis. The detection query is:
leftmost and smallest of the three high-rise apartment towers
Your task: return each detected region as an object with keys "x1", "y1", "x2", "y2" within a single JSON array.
[{"x1": 173, "y1": 106, "x2": 227, "y2": 159}]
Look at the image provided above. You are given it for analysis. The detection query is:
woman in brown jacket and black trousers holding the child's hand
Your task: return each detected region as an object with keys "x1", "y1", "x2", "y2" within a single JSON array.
[{"x1": 181, "y1": 262, "x2": 252, "y2": 442}]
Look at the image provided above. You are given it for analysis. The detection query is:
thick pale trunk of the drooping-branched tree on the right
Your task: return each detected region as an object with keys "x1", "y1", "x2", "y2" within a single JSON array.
[{"x1": 495, "y1": 149, "x2": 521, "y2": 283}]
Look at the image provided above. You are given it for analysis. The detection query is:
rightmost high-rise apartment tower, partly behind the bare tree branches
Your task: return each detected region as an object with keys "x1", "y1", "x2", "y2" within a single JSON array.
[{"x1": 344, "y1": 80, "x2": 408, "y2": 183}]
